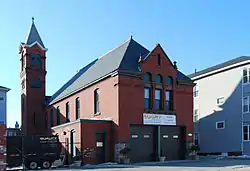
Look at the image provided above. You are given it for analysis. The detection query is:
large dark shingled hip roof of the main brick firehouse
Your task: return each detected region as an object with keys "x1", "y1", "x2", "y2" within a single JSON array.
[{"x1": 49, "y1": 37, "x2": 191, "y2": 105}]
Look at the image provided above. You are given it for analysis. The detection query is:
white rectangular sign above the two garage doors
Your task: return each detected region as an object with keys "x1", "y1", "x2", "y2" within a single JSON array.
[{"x1": 143, "y1": 113, "x2": 176, "y2": 125}]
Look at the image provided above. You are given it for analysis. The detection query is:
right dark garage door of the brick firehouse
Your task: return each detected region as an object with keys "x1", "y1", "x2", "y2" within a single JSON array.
[{"x1": 160, "y1": 126, "x2": 185, "y2": 160}]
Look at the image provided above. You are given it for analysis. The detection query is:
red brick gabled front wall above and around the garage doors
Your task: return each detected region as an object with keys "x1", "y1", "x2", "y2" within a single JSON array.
[{"x1": 119, "y1": 46, "x2": 193, "y2": 141}]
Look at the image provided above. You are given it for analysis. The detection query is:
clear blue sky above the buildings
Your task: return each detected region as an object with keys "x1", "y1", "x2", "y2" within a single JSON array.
[{"x1": 0, "y1": 0, "x2": 250, "y2": 126}]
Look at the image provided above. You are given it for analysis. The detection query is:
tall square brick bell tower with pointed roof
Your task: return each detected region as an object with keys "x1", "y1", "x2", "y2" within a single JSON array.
[{"x1": 19, "y1": 18, "x2": 47, "y2": 135}]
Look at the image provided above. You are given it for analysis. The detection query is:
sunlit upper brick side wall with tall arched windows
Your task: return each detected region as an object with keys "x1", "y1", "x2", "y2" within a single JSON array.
[{"x1": 47, "y1": 76, "x2": 119, "y2": 140}]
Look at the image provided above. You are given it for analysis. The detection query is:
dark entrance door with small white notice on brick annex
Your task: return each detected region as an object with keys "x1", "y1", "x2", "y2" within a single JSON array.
[{"x1": 96, "y1": 133, "x2": 106, "y2": 163}]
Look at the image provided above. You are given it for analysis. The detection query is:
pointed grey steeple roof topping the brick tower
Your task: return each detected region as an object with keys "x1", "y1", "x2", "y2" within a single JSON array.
[{"x1": 25, "y1": 17, "x2": 45, "y2": 49}]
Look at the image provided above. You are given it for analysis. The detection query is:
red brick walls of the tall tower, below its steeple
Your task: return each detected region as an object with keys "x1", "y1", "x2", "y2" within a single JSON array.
[{"x1": 20, "y1": 45, "x2": 46, "y2": 135}]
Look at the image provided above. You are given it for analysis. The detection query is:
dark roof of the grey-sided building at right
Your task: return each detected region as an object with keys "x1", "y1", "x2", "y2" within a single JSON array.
[{"x1": 188, "y1": 56, "x2": 250, "y2": 78}]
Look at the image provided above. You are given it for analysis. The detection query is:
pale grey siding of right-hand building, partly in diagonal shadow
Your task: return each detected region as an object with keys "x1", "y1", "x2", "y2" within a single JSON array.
[{"x1": 194, "y1": 63, "x2": 248, "y2": 153}]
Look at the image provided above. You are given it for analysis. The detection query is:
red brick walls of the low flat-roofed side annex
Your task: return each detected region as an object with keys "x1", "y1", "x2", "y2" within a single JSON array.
[{"x1": 52, "y1": 121, "x2": 114, "y2": 164}]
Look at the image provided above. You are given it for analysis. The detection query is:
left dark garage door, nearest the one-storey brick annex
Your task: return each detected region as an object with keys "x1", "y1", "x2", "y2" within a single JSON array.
[{"x1": 130, "y1": 125, "x2": 156, "y2": 162}]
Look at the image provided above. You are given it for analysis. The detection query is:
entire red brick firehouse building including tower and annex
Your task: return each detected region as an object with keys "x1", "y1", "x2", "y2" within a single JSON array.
[{"x1": 19, "y1": 21, "x2": 194, "y2": 163}]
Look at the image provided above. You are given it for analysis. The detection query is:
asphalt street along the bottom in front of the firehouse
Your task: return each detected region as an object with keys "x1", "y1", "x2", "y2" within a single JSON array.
[{"x1": 39, "y1": 159, "x2": 250, "y2": 171}]
